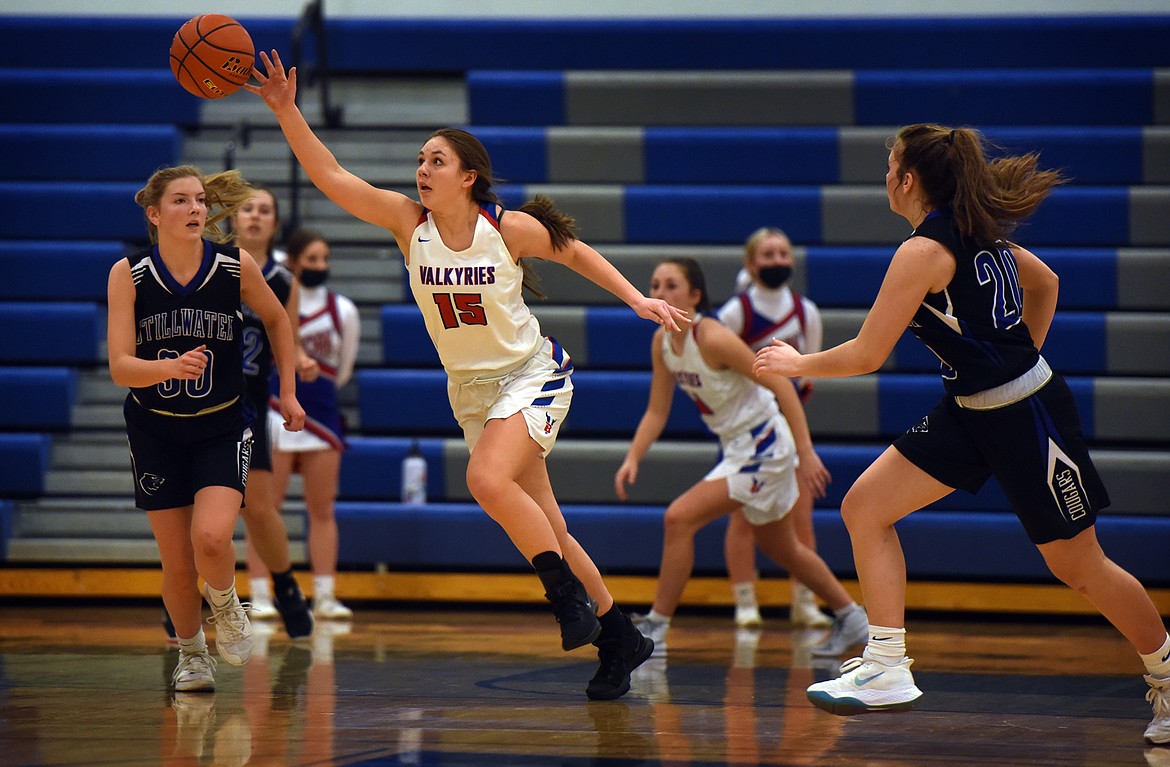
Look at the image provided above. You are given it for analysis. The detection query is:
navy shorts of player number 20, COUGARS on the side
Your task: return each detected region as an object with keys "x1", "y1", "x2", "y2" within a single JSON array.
[{"x1": 894, "y1": 374, "x2": 1109, "y2": 544}]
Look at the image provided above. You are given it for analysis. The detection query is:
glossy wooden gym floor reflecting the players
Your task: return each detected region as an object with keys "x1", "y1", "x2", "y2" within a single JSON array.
[{"x1": 0, "y1": 599, "x2": 1170, "y2": 767}]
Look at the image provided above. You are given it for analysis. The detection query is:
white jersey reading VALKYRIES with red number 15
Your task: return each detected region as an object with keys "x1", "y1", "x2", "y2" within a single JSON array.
[{"x1": 408, "y1": 205, "x2": 544, "y2": 376}]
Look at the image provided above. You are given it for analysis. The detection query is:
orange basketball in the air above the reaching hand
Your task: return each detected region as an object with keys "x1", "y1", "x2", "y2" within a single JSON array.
[{"x1": 171, "y1": 13, "x2": 256, "y2": 98}]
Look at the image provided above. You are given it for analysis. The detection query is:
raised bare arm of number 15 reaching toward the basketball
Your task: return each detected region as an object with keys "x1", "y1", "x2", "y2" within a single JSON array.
[{"x1": 243, "y1": 50, "x2": 422, "y2": 246}]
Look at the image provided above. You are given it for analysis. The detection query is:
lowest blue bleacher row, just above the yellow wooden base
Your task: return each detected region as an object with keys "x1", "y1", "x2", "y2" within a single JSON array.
[{"x1": 337, "y1": 502, "x2": 1170, "y2": 585}]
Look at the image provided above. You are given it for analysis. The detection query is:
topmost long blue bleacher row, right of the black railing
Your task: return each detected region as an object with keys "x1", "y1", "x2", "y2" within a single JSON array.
[{"x1": 315, "y1": 16, "x2": 1170, "y2": 70}]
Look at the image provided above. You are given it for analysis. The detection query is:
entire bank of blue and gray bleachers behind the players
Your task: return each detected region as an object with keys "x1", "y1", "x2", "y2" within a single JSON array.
[{"x1": 0, "y1": 10, "x2": 1170, "y2": 593}]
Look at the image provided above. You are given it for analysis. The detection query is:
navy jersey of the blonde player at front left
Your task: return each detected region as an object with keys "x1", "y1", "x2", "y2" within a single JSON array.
[{"x1": 128, "y1": 241, "x2": 243, "y2": 415}]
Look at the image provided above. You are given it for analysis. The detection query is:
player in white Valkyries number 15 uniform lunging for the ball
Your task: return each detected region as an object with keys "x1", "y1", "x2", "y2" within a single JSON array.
[{"x1": 246, "y1": 51, "x2": 686, "y2": 699}]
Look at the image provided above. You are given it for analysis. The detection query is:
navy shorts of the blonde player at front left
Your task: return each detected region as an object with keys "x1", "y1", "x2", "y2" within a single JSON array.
[{"x1": 123, "y1": 398, "x2": 252, "y2": 511}]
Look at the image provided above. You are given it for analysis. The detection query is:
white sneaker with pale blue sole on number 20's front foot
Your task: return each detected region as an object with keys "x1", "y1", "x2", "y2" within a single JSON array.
[{"x1": 805, "y1": 657, "x2": 922, "y2": 717}]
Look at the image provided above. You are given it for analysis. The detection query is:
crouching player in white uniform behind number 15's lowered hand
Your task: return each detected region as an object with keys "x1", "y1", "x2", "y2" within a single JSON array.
[{"x1": 614, "y1": 258, "x2": 868, "y2": 652}]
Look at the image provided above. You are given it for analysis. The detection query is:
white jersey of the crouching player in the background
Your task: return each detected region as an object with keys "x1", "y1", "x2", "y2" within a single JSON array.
[{"x1": 662, "y1": 315, "x2": 779, "y2": 442}]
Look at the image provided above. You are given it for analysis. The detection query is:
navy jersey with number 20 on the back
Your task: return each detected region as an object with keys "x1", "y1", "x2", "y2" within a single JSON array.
[{"x1": 908, "y1": 210, "x2": 1040, "y2": 396}]
